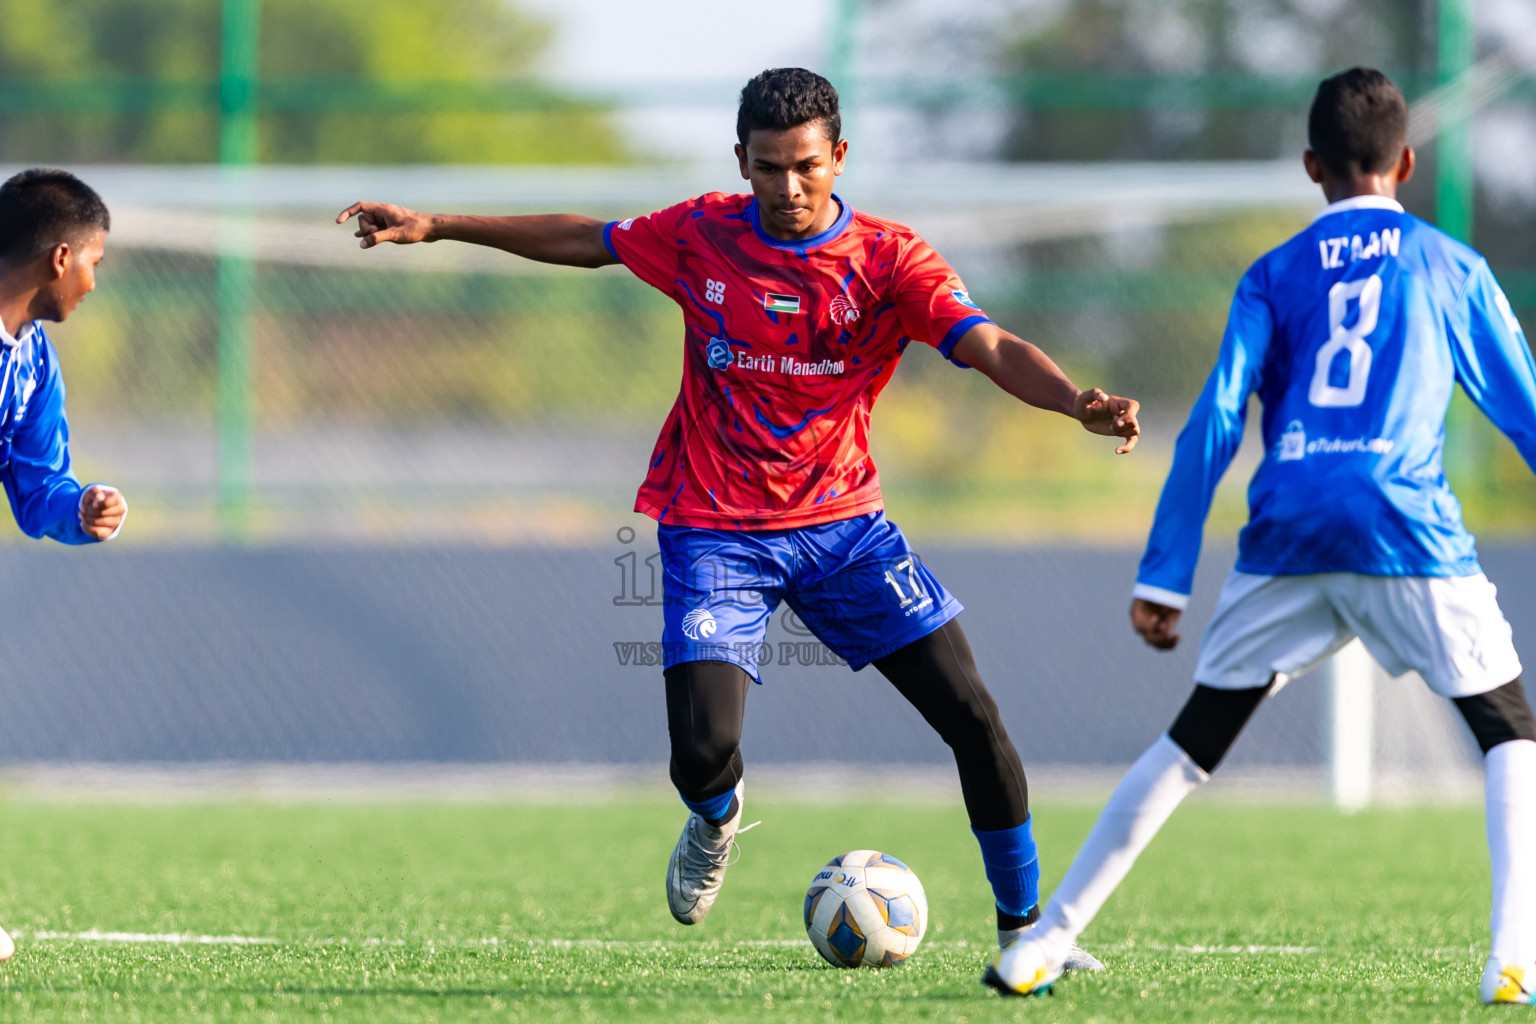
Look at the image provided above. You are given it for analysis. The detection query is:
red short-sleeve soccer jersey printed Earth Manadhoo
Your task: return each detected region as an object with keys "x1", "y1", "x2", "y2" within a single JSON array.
[{"x1": 604, "y1": 192, "x2": 989, "y2": 530}]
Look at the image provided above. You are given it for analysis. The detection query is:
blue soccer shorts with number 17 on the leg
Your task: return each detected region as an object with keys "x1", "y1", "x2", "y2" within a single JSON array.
[{"x1": 656, "y1": 511, "x2": 962, "y2": 682}]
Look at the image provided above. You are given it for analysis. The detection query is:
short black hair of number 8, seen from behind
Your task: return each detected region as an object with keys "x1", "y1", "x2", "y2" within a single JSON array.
[{"x1": 1307, "y1": 68, "x2": 1409, "y2": 178}]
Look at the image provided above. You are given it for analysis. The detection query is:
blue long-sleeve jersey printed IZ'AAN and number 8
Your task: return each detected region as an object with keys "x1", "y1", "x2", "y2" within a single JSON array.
[{"x1": 1135, "y1": 197, "x2": 1536, "y2": 608}]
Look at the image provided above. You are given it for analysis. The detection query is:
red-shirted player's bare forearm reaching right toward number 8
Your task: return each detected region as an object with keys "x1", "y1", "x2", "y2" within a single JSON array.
[{"x1": 951, "y1": 322, "x2": 1141, "y2": 454}]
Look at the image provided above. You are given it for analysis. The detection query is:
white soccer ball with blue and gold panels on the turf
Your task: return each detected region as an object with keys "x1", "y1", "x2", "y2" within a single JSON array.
[{"x1": 805, "y1": 851, "x2": 928, "y2": 967}]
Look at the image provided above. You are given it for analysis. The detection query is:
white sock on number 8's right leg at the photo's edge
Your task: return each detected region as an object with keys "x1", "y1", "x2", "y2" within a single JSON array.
[{"x1": 1487, "y1": 740, "x2": 1536, "y2": 970}]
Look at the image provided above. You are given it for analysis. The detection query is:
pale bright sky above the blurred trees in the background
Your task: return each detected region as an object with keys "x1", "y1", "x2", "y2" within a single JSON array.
[{"x1": 515, "y1": 0, "x2": 1536, "y2": 201}]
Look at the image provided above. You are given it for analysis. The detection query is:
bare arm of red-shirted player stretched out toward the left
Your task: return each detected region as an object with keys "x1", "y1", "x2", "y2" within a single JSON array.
[{"x1": 336, "y1": 203, "x2": 617, "y2": 267}]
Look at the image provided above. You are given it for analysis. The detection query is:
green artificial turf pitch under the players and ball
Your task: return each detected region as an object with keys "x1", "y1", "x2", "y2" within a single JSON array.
[{"x1": 0, "y1": 800, "x2": 1490, "y2": 1024}]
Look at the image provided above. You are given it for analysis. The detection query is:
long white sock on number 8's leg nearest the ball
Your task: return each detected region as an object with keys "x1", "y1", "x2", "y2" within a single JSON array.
[{"x1": 1035, "y1": 734, "x2": 1210, "y2": 956}]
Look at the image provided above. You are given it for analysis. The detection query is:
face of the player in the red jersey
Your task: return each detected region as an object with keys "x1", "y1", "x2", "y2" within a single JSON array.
[{"x1": 736, "y1": 121, "x2": 848, "y2": 239}]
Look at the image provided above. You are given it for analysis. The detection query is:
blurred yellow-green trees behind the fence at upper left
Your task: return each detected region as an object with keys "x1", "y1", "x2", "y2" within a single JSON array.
[{"x1": 0, "y1": 0, "x2": 625, "y2": 164}]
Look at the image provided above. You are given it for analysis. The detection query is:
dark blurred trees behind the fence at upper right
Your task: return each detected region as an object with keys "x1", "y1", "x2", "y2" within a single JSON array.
[{"x1": 1001, "y1": 0, "x2": 1435, "y2": 160}]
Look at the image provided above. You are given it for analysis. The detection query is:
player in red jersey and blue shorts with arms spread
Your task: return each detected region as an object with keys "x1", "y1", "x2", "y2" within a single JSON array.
[{"x1": 345, "y1": 68, "x2": 1140, "y2": 969}]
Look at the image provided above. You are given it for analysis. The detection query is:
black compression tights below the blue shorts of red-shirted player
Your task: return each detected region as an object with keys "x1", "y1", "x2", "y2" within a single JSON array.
[{"x1": 664, "y1": 620, "x2": 1029, "y2": 831}]
